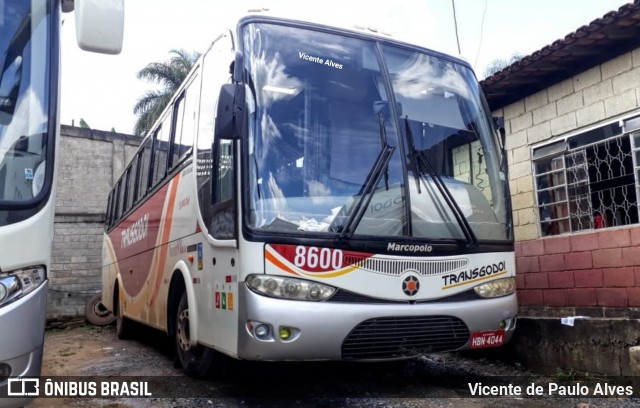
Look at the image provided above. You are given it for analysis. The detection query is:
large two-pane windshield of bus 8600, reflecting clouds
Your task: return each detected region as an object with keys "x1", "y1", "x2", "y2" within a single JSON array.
[{"x1": 243, "y1": 23, "x2": 510, "y2": 241}]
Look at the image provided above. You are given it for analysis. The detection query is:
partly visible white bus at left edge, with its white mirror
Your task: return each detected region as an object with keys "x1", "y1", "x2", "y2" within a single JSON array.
[{"x1": 0, "y1": 0, "x2": 124, "y2": 407}]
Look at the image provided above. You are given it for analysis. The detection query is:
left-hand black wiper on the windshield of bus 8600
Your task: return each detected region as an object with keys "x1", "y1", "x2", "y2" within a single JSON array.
[{"x1": 336, "y1": 113, "x2": 396, "y2": 241}]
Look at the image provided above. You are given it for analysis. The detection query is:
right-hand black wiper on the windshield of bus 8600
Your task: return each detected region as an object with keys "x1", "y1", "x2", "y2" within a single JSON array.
[{"x1": 404, "y1": 115, "x2": 478, "y2": 245}]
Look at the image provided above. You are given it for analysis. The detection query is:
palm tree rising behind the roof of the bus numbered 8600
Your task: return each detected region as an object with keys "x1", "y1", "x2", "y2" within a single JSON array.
[{"x1": 133, "y1": 49, "x2": 200, "y2": 135}]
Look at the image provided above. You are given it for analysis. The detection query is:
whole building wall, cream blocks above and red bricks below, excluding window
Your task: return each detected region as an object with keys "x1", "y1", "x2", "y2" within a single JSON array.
[{"x1": 496, "y1": 49, "x2": 640, "y2": 307}]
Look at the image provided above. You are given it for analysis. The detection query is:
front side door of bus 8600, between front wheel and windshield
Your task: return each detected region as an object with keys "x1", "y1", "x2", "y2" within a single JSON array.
[{"x1": 194, "y1": 33, "x2": 239, "y2": 354}]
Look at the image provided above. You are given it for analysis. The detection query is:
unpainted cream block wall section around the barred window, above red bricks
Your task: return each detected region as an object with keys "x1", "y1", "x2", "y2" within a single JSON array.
[{"x1": 496, "y1": 49, "x2": 640, "y2": 241}]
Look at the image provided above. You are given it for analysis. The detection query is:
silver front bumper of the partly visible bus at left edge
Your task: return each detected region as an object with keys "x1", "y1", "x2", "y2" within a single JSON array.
[{"x1": 0, "y1": 280, "x2": 49, "y2": 408}]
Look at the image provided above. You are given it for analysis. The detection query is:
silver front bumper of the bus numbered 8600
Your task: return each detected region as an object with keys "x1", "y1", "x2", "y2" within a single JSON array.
[{"x1": 237, "y1": 285, "x2": 518, "y2": 361}]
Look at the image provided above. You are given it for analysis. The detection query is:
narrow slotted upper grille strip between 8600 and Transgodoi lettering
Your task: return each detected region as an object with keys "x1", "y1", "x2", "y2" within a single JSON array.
[{"x1": 345, "y1": 255, "x2": 469, "y2": 276}]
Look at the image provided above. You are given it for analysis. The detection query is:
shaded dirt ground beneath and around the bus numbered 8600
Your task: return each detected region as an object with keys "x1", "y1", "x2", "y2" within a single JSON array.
[{"x1": 25, "y1": 325, "x2": 640, "y2": 408}]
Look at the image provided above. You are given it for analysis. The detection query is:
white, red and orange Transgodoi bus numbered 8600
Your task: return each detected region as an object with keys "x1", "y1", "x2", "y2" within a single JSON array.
[{"x1": 102, "y1": 15, "x2": 517, "y2": 376}]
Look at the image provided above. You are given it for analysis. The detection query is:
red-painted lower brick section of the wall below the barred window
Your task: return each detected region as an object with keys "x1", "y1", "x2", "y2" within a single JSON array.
[{"x1": 516, "y1": 227, "x2": 640, "y2": 307}]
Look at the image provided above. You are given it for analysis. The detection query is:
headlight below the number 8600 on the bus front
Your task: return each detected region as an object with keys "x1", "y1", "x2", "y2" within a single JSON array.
[{"x1": 246, "y1": 275, "x2": 336, "y2": 301}]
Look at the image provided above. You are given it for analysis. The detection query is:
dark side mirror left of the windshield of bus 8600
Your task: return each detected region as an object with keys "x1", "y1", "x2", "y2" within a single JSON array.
[{"x1": 216, "y1": 84, "x2": 244, "y2": 139}]
